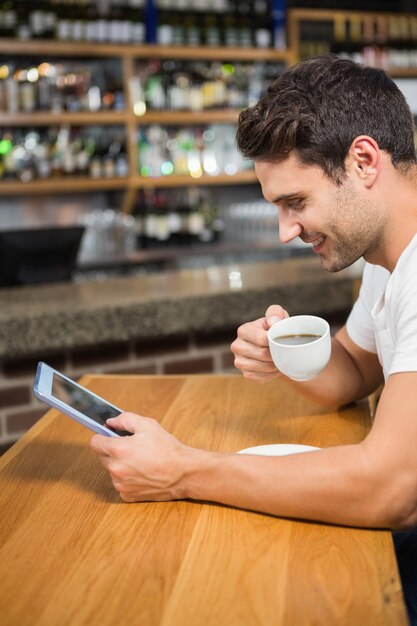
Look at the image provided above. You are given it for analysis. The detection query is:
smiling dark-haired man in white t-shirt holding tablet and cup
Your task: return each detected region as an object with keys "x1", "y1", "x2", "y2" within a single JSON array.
[{"x1": 91, "y1": 56, "x2": 417, "y2": 620}]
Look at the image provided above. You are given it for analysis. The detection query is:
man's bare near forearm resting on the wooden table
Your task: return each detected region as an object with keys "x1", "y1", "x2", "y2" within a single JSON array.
[{"x1": 182, "y1": 445, "x2": 400, "y2": 527}]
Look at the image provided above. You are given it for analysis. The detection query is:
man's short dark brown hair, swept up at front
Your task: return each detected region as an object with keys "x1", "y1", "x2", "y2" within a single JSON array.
[{"x1": 236, "y1": 54, "x2": 416, "y2": 184}]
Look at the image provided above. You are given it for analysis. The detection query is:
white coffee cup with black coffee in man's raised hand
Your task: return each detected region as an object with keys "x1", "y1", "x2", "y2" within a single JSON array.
[{"x1": 268, "y1": 315, "x2": 331, "y2": 381}]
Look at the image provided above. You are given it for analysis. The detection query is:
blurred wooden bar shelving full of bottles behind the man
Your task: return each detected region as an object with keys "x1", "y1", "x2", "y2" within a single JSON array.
[{"x1": 0, "y1": 0, "x2": 417, "y2": 280}]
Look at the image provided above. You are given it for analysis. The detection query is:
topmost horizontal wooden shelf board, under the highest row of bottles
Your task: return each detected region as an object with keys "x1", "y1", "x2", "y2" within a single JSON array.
[{"x1": 0, "y1": 38, "x2": 292, "y2": 63}]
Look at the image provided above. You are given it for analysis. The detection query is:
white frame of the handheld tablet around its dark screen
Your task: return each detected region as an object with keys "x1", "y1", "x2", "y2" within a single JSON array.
[{"x1": 33, "y1": 362, "x2": 132, "y2": 437}]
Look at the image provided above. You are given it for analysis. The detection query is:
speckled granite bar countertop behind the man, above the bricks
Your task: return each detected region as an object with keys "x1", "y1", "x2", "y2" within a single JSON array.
[{"x1": 0, "y1": 257, "x2": 361, "y2": 359}]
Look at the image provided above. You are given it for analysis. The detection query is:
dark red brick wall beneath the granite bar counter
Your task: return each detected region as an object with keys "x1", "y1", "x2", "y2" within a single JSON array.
[{"x1": 0, "y1": 328, "x2": 236, "y2": 452}]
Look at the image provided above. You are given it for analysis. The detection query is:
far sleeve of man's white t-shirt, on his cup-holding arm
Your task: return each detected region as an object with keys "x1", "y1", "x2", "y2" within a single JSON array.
[{"x1": 346, "y1": 264, "x2": 377, "y2": 354}]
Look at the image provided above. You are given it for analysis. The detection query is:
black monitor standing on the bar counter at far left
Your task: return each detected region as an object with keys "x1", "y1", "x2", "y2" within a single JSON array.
[{"x1": 0, "y1": 226, "x2": 84, "y2": 287}]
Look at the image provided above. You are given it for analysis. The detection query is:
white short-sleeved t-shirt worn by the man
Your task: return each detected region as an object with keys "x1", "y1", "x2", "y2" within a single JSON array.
[{"x1": 346, "y1": 235, "x2": 417, "y2": 380}]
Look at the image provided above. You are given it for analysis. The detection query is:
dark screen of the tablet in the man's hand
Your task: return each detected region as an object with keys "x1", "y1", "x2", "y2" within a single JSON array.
[{"x1": 52, "y1": 373, "x2": 120, "y2": 432}]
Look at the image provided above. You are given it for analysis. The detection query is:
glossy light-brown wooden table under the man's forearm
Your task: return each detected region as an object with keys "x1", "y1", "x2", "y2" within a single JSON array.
[{"x1": 0, "y1": 376, "x2": 407, "y2": 626}]
